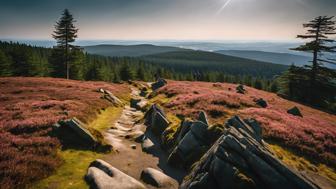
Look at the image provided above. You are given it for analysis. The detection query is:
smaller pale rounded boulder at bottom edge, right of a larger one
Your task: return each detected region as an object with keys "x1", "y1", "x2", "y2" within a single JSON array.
[{"x1": 141, "y1": 168, "x2": 176, "y2": 188}]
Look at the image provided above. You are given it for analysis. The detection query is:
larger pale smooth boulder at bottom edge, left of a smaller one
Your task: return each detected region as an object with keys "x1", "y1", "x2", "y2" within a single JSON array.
[{"x1": 85, "y1": 159, "x2": 146, "y2": 189}]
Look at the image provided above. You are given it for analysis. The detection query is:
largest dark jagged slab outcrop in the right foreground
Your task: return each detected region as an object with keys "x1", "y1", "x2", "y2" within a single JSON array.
[{"x1": 181, "y1": 116, "x2": 319, "y2": 189}]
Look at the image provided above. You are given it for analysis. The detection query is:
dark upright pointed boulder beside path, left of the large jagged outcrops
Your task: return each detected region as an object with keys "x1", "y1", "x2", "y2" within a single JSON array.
[{"x1": 145, "y1": 104, "x2": 169, "y2": 136}]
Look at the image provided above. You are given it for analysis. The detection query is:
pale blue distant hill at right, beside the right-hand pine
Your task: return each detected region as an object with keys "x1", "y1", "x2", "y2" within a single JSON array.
[{"x1": 216, "y1": 50, "x2": 311, "y2": 66}]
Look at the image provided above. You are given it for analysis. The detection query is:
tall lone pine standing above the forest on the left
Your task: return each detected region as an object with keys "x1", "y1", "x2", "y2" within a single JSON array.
[{"x1": 52, "y1": 9, "x2": 78, "y2": 79}]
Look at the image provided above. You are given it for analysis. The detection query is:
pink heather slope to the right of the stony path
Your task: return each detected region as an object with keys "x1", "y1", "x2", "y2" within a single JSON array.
[{"x1": 154, "y1": 81, "x2": 336, "y2": 168}]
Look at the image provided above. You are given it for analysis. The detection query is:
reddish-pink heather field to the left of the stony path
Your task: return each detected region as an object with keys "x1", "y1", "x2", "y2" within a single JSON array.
[{"x1": 0, "y1": 77, "x2": 129, "y2": 188}]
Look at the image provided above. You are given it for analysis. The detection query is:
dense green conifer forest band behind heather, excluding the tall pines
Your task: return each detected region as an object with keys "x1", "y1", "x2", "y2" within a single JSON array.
[{"x1": 0, "y1": 42, "x2": 278, "y2": 92}]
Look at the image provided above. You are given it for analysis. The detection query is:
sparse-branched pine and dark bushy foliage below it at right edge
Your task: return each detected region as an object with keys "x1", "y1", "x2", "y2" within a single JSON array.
[{"x1": 279, "y1": 16, "x2": 336, "y2": 112}]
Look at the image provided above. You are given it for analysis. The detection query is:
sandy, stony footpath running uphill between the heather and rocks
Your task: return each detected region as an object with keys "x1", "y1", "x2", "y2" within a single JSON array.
[{"x1": 103, "y1": 88, "x2": 185, "y2": 188}]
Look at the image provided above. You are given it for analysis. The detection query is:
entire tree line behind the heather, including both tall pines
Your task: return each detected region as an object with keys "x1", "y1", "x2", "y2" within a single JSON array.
[{"x1": 0, "y1": 10, "x2": 336, "y2": 112}]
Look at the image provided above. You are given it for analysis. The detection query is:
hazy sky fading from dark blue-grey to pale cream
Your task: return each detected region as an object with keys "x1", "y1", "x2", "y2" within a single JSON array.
[{"x1": 0, "y1": 0, "x2": 336, "y2": 40}]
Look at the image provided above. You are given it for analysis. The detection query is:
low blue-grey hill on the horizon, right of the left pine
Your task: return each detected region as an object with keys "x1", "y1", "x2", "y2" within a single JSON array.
[{"x1": 82, "y1": 44, "x2": 186, "y2": 57}]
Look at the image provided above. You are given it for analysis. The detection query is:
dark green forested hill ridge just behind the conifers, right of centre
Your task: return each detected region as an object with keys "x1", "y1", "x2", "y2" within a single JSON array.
[{"x1": 142, "y1": 50, "x2": 288, "y2": 78}]
